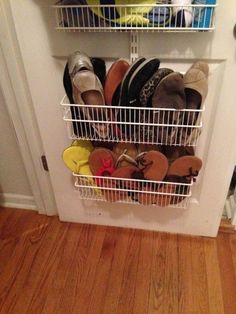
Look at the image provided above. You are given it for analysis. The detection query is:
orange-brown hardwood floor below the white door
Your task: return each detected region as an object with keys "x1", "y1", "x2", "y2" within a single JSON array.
[{"x1": 0, "y1": 209, "x2": 236, "y2": 314}]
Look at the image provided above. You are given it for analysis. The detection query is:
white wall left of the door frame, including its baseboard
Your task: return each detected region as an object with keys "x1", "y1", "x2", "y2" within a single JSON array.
[{"x1": 0, "y1": 88, "x2": 34, "y2": 208}]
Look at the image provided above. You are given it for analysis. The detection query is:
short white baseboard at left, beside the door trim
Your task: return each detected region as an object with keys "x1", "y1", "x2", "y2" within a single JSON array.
[{"x1": 0, "y1": 193, "x2": 37, "y2": 210}]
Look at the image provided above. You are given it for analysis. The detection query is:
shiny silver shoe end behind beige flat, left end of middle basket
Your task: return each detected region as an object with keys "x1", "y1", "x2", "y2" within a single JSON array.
[{"x1": 68, "y1": 51, "x2": 93, "y2": 80}]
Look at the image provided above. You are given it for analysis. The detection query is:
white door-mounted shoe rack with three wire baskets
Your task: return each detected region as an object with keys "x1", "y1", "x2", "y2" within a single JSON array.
[{"x1": 53, "y1": 1, "x2": 216, "y2": 208}]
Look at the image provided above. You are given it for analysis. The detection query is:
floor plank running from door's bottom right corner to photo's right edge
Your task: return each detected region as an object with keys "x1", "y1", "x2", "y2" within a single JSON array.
[{"x1": 216, "y1": 233, "x2": 236, "y2": 314}]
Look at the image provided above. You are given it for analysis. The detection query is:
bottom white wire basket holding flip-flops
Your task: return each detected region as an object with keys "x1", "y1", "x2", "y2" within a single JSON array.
[{"x1": 73, "y1": 174, "x2": 192, "y2": 208}]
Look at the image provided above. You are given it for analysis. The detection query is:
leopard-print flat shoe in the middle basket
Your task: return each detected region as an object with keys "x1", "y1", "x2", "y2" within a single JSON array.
[{"x1": 139, "y1": 68, "x2": 174, "y2": 107}]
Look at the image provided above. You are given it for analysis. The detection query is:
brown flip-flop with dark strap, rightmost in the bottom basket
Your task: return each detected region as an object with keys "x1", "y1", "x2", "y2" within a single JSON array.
[{"x1": 167, "y1": 156, "x2": 202, "y2": 182}]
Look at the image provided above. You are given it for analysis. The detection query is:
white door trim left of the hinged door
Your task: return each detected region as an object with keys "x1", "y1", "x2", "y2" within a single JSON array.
[{"x1": 0, "y1": 0, "x2": 57, "y2": 215}]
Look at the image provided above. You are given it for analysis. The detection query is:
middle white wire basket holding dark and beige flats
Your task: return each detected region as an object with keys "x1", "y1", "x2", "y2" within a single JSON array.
[{"x1": 60, "y1": 96, "x2": 205, "y2": 146}]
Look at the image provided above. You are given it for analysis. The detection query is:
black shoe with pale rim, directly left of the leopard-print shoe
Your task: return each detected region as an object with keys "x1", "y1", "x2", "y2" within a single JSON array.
[{"x1": 128, "y1": 58, "x2": 160, "y2": 107}]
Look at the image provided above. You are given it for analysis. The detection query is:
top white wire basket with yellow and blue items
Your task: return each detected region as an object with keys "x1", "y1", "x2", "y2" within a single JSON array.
[{"x1": 53, "y1": 0, "x2": 216, "y2": 32}]
